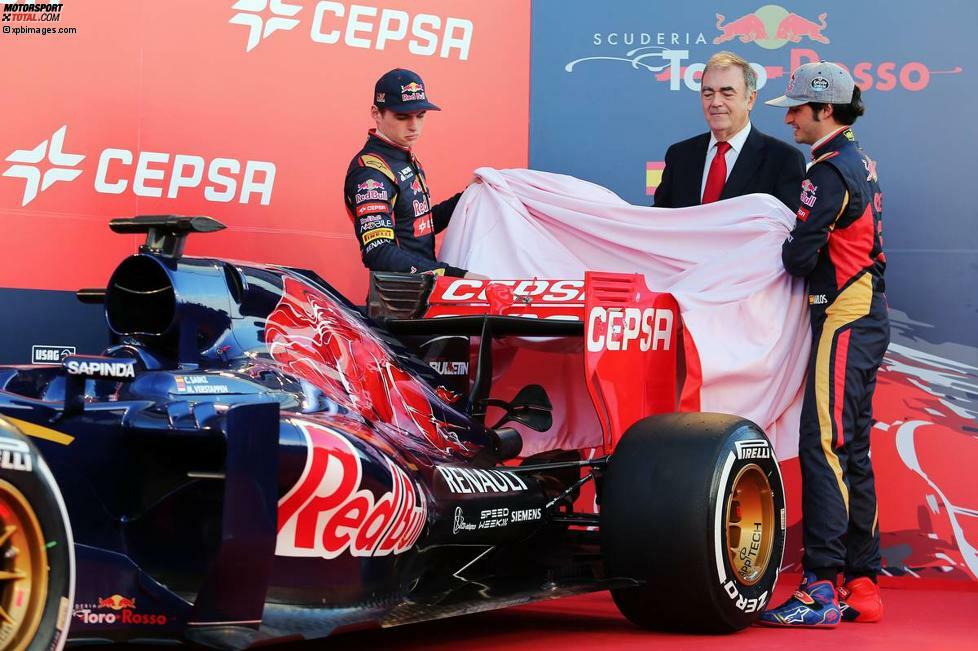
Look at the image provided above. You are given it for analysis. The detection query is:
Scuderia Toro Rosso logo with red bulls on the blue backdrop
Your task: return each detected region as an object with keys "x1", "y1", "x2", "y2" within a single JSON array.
[{"x1": 564, "y1": 5, "x2": 961, "y2": 93}]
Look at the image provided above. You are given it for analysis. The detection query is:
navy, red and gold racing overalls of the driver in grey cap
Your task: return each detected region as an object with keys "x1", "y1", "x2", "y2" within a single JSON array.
[{"x1": 782, "y1": 127, "x2": 890, "y2": 576}]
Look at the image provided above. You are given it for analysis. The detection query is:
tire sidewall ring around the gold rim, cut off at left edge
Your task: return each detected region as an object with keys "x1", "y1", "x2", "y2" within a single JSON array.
[{"x1": 0, "y1": 427, "x2": 75, "y2": 651}]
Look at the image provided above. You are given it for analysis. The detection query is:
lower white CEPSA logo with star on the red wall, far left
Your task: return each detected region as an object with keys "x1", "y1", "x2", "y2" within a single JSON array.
[{"x1": 3, "y1": 124, "x2": 275, "y2": 206}]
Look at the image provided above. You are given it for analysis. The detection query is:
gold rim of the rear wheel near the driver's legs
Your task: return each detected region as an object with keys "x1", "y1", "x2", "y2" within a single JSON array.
[{"x1": 726, "y1": 463, "x2": 776, "y2": 586}]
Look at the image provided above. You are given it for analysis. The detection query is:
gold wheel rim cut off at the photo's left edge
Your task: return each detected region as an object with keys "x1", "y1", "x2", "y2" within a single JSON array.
[{"x1": 0, "y1": 479, "x2": 48, "y2": 651}]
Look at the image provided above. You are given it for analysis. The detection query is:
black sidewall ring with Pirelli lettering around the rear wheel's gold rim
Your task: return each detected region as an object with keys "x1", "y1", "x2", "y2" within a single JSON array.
[{"x1": 709, "y1": 421, "x2": 786, "y2": 628}]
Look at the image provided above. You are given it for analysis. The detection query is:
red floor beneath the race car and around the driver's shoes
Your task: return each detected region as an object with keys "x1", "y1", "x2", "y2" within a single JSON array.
[{"x1": 318, "y1": 575, "x2": 978, "y2": 651}]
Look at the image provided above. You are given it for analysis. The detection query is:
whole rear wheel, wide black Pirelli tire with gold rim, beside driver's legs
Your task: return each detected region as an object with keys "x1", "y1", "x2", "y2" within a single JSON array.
[{"x1": 601, "y1": 413, "x2": 785, "y2": 633}]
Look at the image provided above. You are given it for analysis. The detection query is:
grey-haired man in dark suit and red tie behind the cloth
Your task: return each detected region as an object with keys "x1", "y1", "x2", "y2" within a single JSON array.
[{"x1": 654, "y1": 52, "x2": 805, "y2": 212}]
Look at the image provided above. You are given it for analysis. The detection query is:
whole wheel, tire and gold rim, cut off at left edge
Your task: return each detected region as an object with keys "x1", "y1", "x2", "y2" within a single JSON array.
[{"x1": 0, "y1": 417, "x2": 75, "y2": 651}]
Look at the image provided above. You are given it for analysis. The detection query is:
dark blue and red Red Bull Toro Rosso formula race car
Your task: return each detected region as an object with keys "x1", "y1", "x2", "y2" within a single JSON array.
[{"x1": 0, "y1": 216, "x2": 785, "y2": 651}]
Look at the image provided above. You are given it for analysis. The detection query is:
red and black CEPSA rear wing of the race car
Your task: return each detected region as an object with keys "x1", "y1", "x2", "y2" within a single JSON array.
[{"x1": 368, "y1": 271, "x2": 685, "y2": 453}]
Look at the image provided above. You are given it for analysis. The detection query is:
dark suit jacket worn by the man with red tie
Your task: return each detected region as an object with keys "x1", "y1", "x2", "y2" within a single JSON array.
[{"x1": 653, "y1": 125, "x2": 805, "y2": 211}]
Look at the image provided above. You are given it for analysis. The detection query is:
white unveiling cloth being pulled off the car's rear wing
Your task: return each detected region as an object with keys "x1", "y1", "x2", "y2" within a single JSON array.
[{"x1": 439, "y1": 168, "x2": 811, "y2": 459}]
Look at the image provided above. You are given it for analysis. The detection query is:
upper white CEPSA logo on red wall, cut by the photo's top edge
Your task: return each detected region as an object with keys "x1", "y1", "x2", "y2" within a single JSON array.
[{"x1": 228, "y1": 0, "x2": 474, "y2": 61}]
